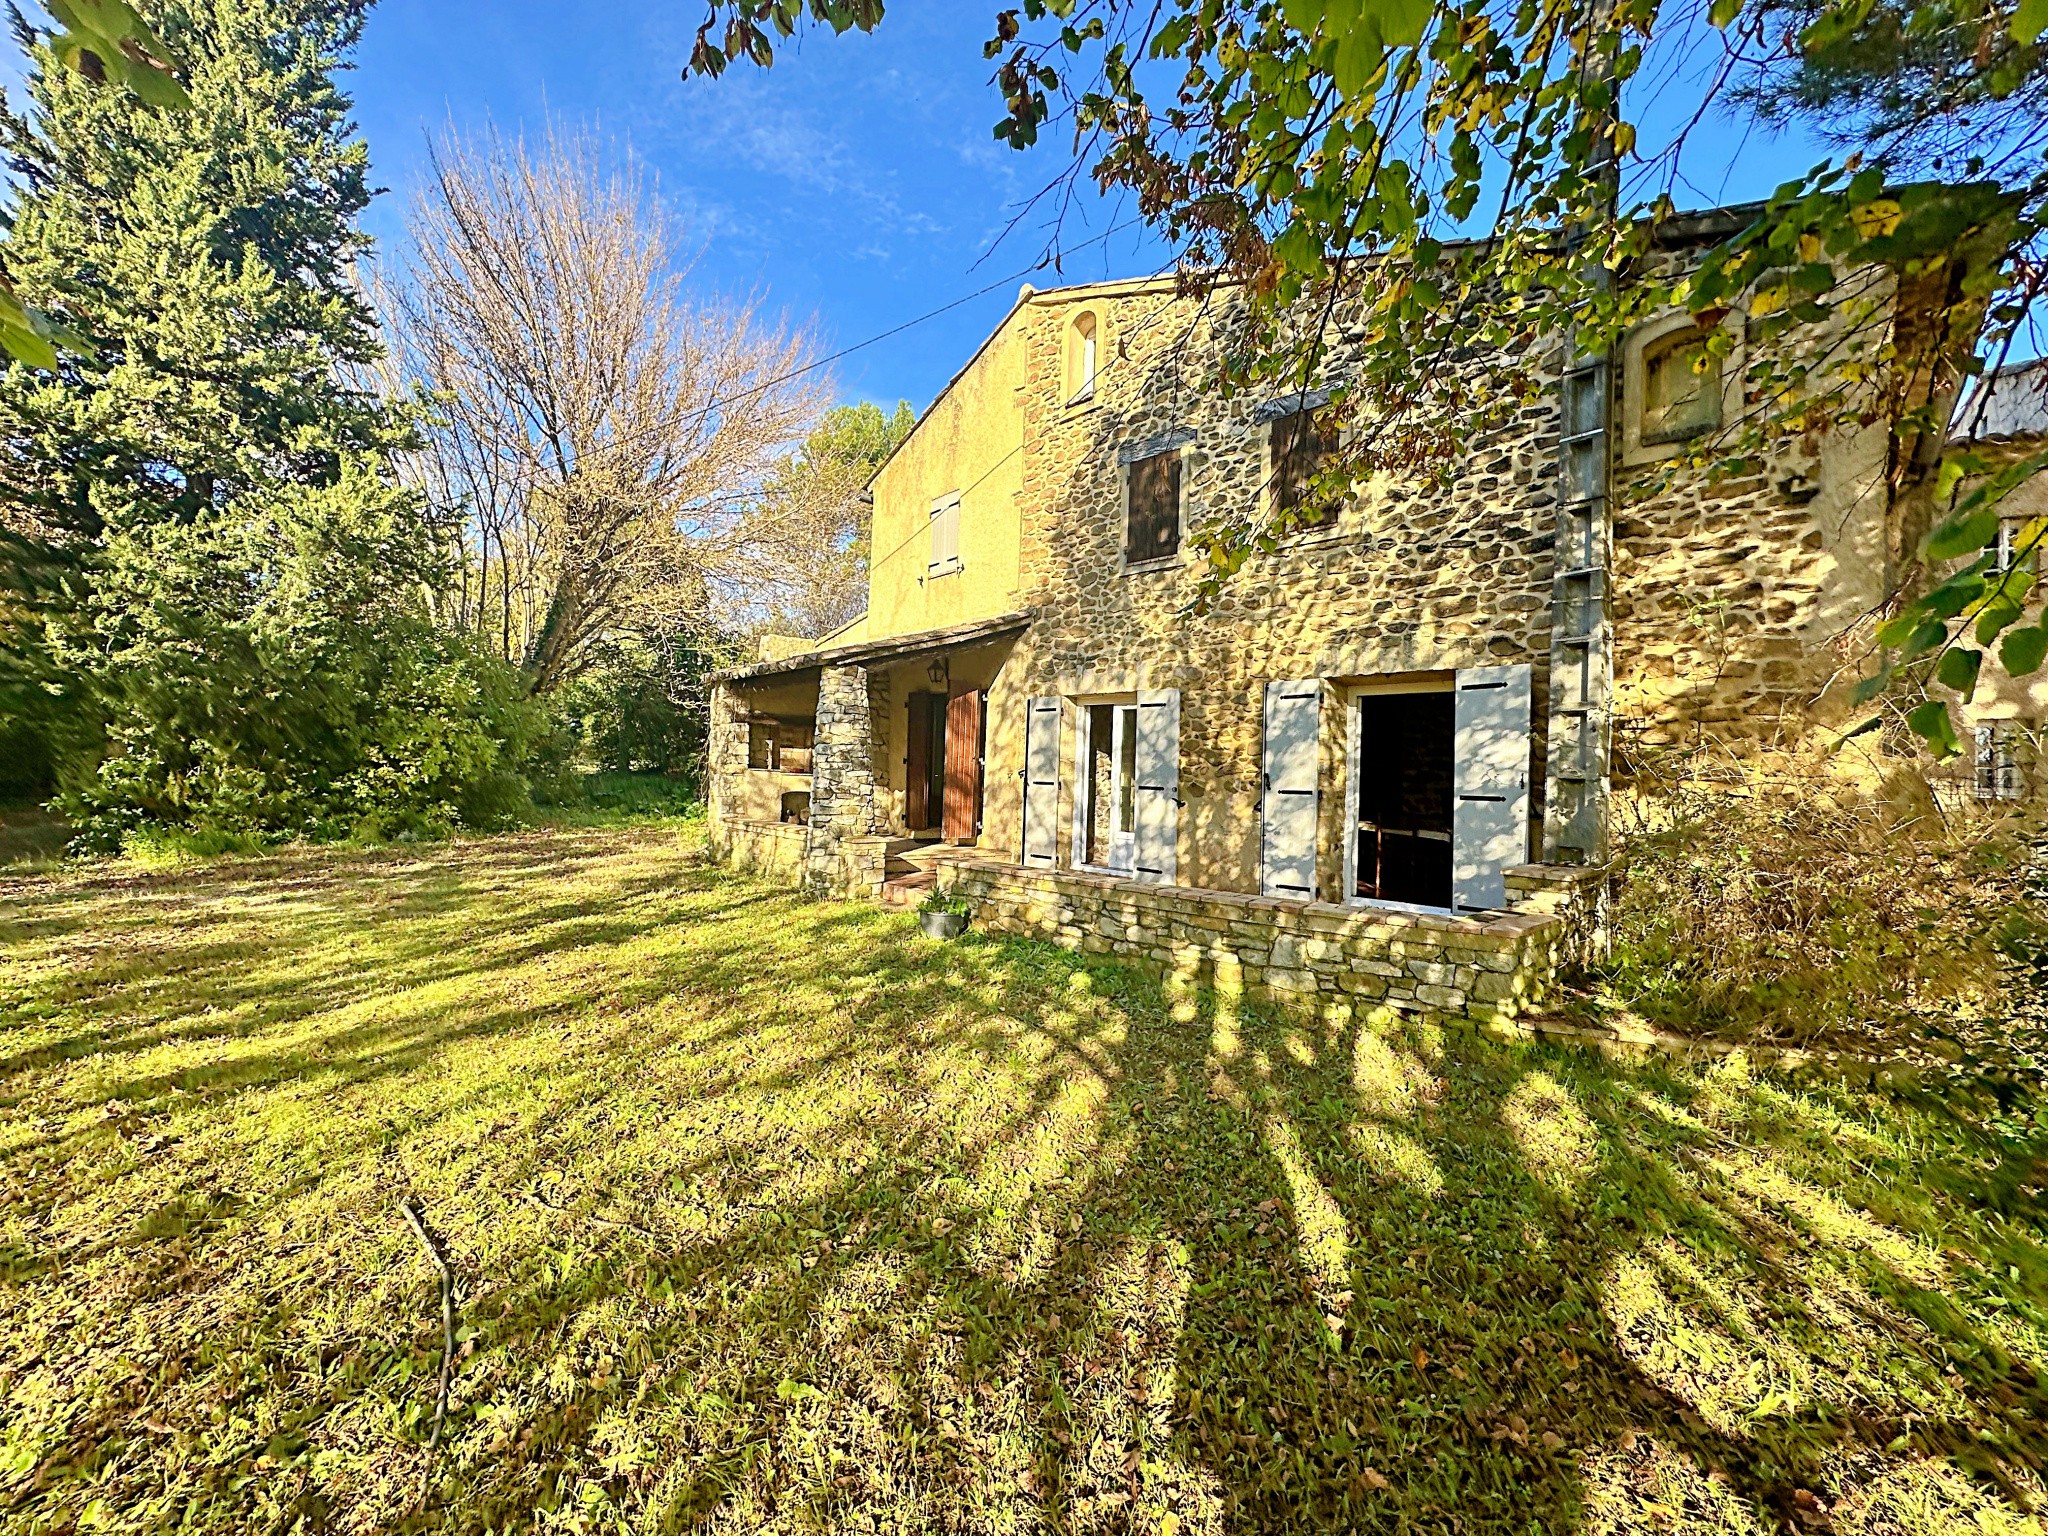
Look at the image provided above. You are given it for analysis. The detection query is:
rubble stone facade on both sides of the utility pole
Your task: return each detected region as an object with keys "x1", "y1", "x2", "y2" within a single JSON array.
[{"x1": 958, "y1": 268, "x2": 1886, "y2": 897}]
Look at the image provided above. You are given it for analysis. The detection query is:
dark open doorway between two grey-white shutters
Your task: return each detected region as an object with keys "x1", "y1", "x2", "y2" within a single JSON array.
[{"x1": 1356, "y1": 690, "x2": 1456, "y2": 907}]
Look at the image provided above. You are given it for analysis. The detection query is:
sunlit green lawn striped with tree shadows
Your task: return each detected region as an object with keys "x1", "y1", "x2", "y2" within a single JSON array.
[{"x1": 0, "y1": 825, "x2": 2048, "y2": 1536}]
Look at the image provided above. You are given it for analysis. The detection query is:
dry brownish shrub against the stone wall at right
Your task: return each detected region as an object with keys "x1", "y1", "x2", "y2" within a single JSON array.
[{"x1": 1597, "y1": 754, "x2": 2028, "y2": 1042}]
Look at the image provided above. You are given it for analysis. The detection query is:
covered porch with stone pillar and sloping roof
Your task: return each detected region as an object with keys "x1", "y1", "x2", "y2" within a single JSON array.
[{"x1": 711, "y1": 612, "x2": 1030, "y2": 897}]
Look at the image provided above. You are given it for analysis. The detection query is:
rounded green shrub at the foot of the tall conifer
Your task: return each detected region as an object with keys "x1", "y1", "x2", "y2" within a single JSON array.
[{"x1": 53, "y1": 465, "x2": 547, "y2": 850}]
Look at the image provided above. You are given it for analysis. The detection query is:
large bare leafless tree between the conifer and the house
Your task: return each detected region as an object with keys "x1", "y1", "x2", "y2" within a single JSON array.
[{"x1": 391, "y1": 131, "x2": 827, "y2": 692}]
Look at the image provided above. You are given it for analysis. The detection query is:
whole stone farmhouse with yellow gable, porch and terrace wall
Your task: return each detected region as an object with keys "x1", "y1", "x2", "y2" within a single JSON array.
[{"x1": 711, "y1": 201, "x2": 1998, "y2": 1020}]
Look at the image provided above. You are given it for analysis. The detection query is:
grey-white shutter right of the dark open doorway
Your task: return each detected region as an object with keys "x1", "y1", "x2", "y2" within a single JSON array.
[{"x1": 1450, "y1": 666, "x2": 1530, "y2": 911}]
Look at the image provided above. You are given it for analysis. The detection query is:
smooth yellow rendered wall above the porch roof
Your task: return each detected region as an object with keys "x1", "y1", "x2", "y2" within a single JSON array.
[{"x1": 862, "y1": 317, "x2": 1024, "y2": 641}]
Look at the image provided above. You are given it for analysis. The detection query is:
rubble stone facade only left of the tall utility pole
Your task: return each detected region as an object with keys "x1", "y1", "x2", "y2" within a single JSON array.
[{"x1": 983, "y1": 285, "x2": 1556, "y2": 897}]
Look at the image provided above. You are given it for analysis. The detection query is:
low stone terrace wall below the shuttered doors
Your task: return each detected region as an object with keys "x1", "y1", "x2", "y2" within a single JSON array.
[{"x1": 938, "y1": 858, "x2": 1577, "y2": 1024}]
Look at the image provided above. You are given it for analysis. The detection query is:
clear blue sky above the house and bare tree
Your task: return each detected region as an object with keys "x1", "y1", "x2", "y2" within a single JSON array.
[{"x1": 350, "y1": 0, "x2": 1843, "y2": 408}]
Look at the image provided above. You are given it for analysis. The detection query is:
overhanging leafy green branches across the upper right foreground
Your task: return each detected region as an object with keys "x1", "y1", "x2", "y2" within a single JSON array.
[{"x1": 690, "y1": 0, "x2": 2048, "y2": 750}]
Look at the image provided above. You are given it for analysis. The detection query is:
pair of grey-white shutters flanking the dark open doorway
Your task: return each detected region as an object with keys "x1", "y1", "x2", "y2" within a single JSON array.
[{"x1": 1260, "y1": 666, "x2": 1530, "y2": 911}]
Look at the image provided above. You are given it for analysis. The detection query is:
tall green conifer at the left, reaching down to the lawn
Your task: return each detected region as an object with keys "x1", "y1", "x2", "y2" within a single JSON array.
[{"x1": 0, "y1": 0, "x2": 528, "y2": 840}]
